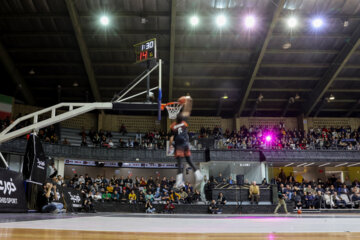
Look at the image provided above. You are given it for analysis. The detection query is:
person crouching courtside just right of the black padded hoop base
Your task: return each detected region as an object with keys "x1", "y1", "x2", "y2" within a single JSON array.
[{"x1": 38, "y1": 183, "x2": 66, "y2": 213}]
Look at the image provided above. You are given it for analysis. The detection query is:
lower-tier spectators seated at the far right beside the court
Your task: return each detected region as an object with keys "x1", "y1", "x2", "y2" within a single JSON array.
[{"x1": 276, "y1": 170, "x2": 360, "y2": 209}]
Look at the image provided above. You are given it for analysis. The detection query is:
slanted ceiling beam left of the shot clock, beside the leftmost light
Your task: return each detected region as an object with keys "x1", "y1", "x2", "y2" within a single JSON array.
[{"x1": 65, "y1": 0, "x2": 101, "y2": 102}]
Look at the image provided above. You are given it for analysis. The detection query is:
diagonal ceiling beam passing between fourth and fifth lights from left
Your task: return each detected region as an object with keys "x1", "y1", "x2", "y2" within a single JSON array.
[{"x1": 237, "y1": 0, "x2": 285, "y2": 116}]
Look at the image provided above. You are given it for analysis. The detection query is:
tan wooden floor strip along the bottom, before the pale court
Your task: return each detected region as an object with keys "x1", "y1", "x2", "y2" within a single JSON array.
[{"x1": 0, "y1": 229, "x2": 360, "y2": 240}]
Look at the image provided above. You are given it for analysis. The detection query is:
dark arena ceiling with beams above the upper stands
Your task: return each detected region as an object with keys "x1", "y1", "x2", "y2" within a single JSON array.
[{"x1": 0, "y1": 0, "x2": 360, "y2": 117}]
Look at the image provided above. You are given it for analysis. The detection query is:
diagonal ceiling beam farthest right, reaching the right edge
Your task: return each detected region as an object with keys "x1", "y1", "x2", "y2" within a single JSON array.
[{"x1": 304, "y1": 22, "x2": 360, "y2": 117}]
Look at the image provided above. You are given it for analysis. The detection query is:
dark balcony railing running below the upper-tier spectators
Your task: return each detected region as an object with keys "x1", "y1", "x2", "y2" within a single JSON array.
[{"x1": 0, "y1": 139, "x2": 360, "y2": 162}]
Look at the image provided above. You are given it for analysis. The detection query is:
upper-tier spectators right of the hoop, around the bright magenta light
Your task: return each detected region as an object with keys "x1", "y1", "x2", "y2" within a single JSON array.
[{"x1": 205, "y1": 124, "x2": 360, "y2": 151}]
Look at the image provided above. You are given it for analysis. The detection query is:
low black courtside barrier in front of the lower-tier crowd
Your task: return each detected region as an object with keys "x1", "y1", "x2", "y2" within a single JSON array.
[{"x1": 95, "y1": 202, "x2": 293, "y2": 214}]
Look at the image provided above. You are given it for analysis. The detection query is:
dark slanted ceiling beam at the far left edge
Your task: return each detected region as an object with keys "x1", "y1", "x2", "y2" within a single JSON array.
[{"x1": 0, "y1": 42, "x2": 35, "y2": 105}]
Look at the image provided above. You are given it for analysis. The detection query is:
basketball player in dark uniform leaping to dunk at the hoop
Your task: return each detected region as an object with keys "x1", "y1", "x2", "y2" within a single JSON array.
[{"x1": 170, "y1": 96, "x2": 203, "y2": 189}]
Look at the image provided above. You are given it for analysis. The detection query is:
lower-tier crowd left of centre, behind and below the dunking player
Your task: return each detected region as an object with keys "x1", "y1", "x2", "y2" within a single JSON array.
[{"x1": 60, "y1": 174, "x2": 201, "y2": 213}]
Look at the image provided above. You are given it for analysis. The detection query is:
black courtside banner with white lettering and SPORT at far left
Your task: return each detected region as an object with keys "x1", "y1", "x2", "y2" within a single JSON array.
[{"x1": 0, "y1": 168, "x2": 26, "y2": 212}]
